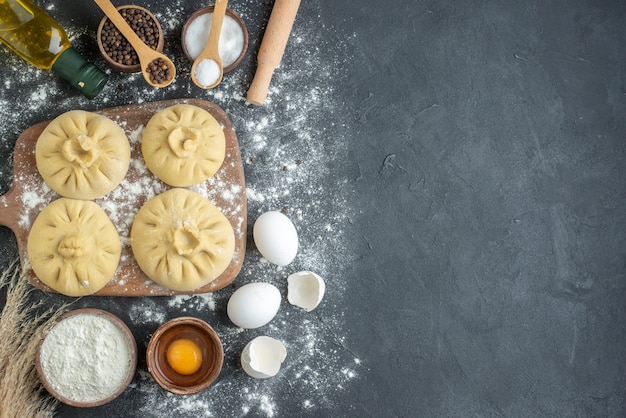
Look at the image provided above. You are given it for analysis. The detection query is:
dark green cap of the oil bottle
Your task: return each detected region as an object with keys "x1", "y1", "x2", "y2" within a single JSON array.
[{"x1": 52, "y1": 47, "x2": 109, "y2": 99}]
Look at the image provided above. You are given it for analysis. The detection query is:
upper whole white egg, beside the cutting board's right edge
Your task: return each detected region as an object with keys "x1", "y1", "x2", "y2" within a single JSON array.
[{"x1": 252, "y1": 211, "x2": 298, "y2": 266}]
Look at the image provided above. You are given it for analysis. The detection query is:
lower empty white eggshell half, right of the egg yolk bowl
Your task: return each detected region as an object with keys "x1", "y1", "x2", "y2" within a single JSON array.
[{"x1": 241, "y1": 336, "x2": 287, "y2": 379}]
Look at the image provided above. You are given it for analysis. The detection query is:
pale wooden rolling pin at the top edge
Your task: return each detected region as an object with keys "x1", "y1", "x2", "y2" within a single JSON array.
[{"x1": 246, "y1": 0, "x2": 300, "y2": 106}]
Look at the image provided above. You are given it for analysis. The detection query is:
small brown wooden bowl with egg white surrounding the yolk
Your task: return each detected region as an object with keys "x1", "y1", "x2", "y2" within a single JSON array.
[{"x1": 146, "y1": 317, "x2": 224, "y2": 395}]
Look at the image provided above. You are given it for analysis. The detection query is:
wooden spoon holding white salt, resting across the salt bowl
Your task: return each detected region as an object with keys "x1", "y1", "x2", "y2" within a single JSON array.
[{"x1": 191, "y1": 0, "x2": 228, "y2": 89}]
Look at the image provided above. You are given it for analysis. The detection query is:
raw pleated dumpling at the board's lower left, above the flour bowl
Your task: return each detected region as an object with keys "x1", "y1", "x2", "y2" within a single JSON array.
[{"x1": 27, "y1": 197, "x2": 122, "y2": 296}]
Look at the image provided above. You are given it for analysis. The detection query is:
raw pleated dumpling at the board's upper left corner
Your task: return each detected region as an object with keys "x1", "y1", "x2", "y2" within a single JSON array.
[{"x1": 35, "y1": 110, "x2": 130, "y2": 200}]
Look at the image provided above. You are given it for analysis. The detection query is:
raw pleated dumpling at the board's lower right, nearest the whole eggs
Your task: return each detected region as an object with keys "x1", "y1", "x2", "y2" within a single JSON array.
[{"x1": 130, "y1": 188, "x2": 235, "y2": 291}]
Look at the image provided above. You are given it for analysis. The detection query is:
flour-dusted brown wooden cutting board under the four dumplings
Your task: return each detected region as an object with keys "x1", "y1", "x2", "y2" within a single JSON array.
[{"x1": 0, "y1": 99, "x2": 247, "y2": 296}]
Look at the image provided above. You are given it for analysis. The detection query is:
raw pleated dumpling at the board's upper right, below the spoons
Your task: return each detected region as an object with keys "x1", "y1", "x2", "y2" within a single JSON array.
[{"x1": 141, "y1": 104, "x2": 226, "y2": 187}]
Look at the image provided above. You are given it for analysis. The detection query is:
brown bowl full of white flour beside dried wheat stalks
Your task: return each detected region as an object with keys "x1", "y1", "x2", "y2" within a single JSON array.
[{"x1": 35, "y1": 308, "x2": 137, "y2": 408}]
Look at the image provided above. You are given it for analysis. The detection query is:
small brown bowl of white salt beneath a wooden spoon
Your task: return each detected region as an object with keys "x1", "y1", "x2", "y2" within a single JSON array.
[{"x1": 181, "y1": 6, "x2": 248, "y2": 74}]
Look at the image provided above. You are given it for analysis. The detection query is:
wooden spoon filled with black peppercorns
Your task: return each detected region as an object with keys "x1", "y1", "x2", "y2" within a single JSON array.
[{"x1": 94, "y1": 0, "x2": 176, "y2": 87}]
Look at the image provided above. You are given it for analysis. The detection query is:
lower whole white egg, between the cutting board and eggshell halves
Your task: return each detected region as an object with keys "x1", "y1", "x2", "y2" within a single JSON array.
[{"x1": 226, "y1": 283, "x2": 281, "y2": 329}]
